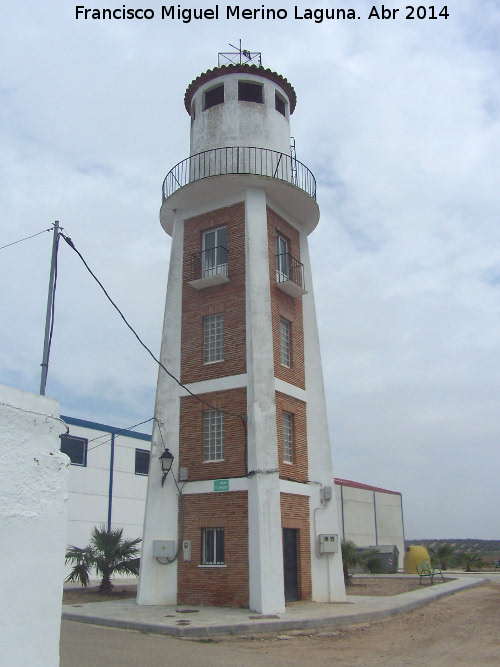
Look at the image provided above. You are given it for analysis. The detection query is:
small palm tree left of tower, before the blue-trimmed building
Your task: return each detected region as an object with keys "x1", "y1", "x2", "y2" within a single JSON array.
[{"x1": 66, "y1": 526, "x2": 141, "y2": 593}]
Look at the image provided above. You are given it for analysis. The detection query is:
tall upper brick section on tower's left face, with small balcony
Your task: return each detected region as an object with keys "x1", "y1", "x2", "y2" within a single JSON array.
[{"x1": 181, "y1": 203, "x2": 246, "y2": 383}]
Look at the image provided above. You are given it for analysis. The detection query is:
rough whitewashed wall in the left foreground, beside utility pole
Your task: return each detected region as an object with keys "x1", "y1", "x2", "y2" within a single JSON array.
[{"x1": 0, "y1": 386, "x2": 69, "y2": 667}]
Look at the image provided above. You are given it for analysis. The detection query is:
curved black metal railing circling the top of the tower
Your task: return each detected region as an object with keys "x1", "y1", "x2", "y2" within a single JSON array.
[{"x1": 163, "y1": 146, "x2": 316, "y2": 201}]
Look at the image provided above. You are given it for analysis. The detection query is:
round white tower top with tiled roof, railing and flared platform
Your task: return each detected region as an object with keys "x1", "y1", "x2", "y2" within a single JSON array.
[{"x1": 160, "y1": 63, "x2": 319, "y2": 235}]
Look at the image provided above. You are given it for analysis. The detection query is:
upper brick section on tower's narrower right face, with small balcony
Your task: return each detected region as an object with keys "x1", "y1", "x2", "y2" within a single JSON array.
[{"x1": 267, "y1": 207, "x2": 305, "y2": 389}]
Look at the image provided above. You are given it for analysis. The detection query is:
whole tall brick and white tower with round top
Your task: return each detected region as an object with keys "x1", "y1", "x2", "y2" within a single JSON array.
[{"x1": 137, "y1": 51, "x2": 345, "y2": 614}]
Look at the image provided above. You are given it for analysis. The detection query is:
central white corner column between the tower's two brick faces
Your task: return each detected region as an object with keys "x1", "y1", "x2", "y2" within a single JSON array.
[{"x1": 245, "y1": 188, "x2": 285, "y2": 614}]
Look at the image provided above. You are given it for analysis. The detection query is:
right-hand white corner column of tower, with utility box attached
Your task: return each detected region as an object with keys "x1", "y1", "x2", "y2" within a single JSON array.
[{"x1": 300, "y1": 234, "x2": 346, "y2": 602}]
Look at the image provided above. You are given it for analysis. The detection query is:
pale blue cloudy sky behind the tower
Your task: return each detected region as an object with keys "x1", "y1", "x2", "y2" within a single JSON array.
[{"x1": 0, "y1": 0, "x2": 500, "y2": 539}]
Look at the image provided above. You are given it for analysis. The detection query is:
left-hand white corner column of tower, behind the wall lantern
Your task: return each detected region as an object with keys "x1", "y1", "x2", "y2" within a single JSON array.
[{"x1": 137, "y1": 215, "x2": 184, "y2": 605}]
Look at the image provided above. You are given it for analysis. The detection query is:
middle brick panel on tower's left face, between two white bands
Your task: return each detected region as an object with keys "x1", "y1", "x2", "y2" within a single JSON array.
[{"x1": 179, "y1": 388, "x2": 247, "y2": 481}]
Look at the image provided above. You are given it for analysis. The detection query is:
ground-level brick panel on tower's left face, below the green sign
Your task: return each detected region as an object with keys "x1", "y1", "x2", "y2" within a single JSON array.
[{"x1": 177, "y1": 491, "x2": 250, "y2": 607}]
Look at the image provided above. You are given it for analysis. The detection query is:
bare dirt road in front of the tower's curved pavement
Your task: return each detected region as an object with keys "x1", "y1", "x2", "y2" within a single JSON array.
[{"x1": 61, "y1": 579, "x2": 500, "y2": 667}]
